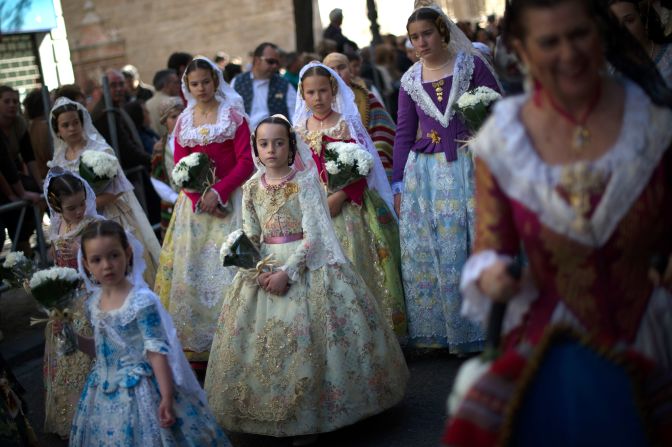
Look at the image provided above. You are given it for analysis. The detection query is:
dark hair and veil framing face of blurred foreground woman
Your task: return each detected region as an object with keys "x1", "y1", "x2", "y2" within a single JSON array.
[{"x1": 503, "y1": 0, "x2": 672, "y2": 108}]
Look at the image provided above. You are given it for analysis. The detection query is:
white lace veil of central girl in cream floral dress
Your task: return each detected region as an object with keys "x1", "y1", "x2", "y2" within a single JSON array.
[{"x1": 251, "y1": 115, "x2": 346, "y2": 270}]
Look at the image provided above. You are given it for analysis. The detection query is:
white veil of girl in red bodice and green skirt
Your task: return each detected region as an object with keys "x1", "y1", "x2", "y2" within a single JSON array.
[{"x1": 294, "y1": 61, "x2": 396, "y2": 216}]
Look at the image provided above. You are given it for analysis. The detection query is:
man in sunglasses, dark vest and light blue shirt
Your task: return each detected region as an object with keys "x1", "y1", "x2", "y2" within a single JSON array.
[{"x1": 231, "y1": 42, "x2": 296, "y2": 129}]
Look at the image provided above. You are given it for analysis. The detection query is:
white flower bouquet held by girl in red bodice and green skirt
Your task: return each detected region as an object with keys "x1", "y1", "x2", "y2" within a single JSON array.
[{"x1": 324, "y1": 142, "x2": 373, "y2": 192}]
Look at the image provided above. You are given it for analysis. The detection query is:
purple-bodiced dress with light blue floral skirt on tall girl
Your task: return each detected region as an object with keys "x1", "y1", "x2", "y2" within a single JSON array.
[{"x1": 392, "y1": 52, "x2": 499, "y2": 353}]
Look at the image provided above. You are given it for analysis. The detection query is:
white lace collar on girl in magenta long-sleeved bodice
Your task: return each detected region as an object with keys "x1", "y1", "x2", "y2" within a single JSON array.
[{"x1": 175, "y1": 98, "x2": 243, "y2": 147}]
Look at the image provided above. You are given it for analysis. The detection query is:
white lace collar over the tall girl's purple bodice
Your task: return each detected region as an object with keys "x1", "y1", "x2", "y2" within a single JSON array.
[{"x1": 401, "y1": 52, "x2": 474, "y2": 127}]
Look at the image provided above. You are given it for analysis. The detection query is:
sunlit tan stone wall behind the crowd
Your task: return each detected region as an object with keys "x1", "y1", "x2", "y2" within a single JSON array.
[{"x1": 61, "y1": 0, "x2": 295, "y2": 83}]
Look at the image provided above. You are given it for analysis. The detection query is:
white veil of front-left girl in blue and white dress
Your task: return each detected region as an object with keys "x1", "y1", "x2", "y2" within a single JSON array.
[{"x1": 77, "y1": 231, "x2": 207, "y2": 403}]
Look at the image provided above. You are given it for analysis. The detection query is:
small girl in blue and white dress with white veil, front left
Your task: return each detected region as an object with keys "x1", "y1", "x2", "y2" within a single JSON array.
[{"x1": 70, "y1": 220, "x2": 230, "y2": 447}]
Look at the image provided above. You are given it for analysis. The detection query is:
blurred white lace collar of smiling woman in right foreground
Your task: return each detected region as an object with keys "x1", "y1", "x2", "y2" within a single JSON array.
[{"x1": 472, "y1": 82, "x2": 672, "y2": 247}]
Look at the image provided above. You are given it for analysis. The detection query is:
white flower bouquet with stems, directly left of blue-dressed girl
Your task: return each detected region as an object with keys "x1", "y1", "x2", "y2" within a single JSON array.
[{"x1": 29, "y1": 267, "x2": 82, "y2": 356}]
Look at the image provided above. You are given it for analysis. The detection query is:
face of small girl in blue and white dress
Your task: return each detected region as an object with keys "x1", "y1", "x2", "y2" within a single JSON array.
[{"x1": 84, "y1": 236, "x2": 131, "y2": 287}]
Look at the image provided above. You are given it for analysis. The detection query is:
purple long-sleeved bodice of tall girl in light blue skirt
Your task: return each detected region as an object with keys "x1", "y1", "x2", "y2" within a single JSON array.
[{"x1": 392, "y1": 53, "x2": 500, "y2": 188}]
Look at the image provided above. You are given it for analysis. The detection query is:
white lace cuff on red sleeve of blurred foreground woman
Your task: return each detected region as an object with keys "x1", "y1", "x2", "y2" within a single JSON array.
[{"x1": 460, "y1": 250, "x2": 538, "y2": 333}]
